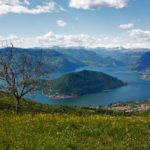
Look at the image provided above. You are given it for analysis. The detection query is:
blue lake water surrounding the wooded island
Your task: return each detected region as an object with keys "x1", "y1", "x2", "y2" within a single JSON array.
[{"x1": 28, "y1": 67, "x2": 150, "y2": 106}]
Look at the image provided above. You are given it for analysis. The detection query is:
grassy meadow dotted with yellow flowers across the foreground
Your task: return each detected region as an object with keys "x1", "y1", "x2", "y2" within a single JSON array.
[{"x1": 0, "y1": 112, "x2": 150, "y2": 150}]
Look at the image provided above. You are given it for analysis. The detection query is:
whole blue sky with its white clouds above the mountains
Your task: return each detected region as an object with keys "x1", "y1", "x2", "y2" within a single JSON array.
[{"x1": 0, "y1": 0, "x2": 150, "y2": 49}]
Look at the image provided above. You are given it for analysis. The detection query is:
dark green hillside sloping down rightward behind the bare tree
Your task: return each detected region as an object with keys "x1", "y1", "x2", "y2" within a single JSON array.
[{"x1": 0, "y1": 92, "x2": 124, "y2": 115}]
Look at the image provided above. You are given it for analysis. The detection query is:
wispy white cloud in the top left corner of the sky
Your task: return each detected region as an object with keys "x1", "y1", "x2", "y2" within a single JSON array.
[{"x1": 0, "y1": 0, "x2": 63, "y2": 15}]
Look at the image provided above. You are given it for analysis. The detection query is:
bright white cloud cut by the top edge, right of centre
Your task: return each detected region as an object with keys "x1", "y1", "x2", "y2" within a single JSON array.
[{"x1": 69, "y1": 0, "x2": 128, "y2": 9}]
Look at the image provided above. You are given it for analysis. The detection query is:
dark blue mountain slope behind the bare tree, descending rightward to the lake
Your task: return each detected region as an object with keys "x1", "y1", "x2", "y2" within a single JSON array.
[{"x1": 0, "y1": 48, "x2": 83, "y2": 72}]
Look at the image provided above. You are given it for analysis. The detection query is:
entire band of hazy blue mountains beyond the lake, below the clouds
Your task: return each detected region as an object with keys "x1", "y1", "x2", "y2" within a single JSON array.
[{"x1": 0, "y1": 47, "x2": 150, "y2": 72}]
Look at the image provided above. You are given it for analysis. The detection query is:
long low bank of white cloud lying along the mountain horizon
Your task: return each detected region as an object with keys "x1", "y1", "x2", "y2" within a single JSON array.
[{"x1": 0, "y1": 29, "x2": 150, "y2": 49}]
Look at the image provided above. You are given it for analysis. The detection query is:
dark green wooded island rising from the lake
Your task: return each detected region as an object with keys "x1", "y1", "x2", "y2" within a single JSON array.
[{"x1": 43, "y1": 70, "x2": 127, "y2": 99}]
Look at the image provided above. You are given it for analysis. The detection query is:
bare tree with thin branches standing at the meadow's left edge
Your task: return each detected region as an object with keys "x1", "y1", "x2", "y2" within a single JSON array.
[{"x1": 0, "y1": 44, "x2": 44, "y2": 112}]
